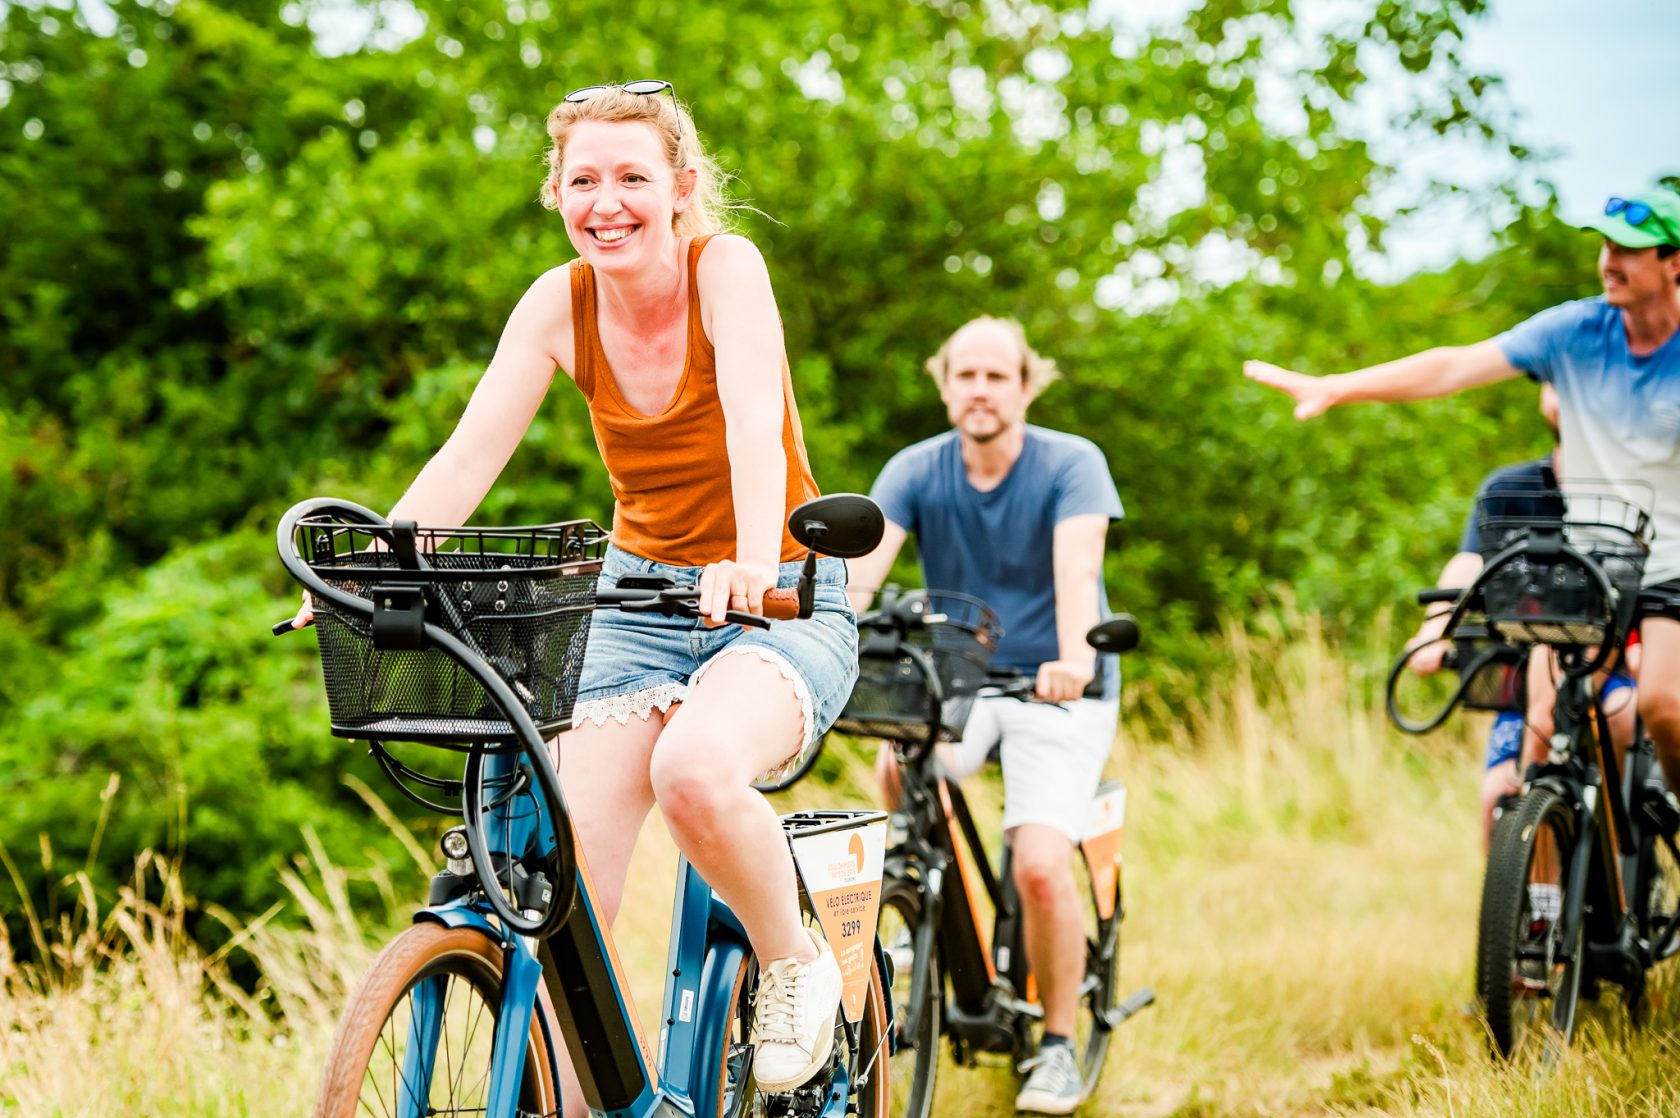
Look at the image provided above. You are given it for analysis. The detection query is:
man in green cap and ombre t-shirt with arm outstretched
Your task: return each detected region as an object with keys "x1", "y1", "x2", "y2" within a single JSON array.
[{"x1": 1243, "y1": 188, "x2": 1680, "y2": 827}]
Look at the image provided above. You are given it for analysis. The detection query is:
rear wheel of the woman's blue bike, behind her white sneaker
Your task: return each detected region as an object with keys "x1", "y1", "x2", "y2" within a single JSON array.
[{"x1": 717, "y1": 928, "x2": 892, "y2": 1118}]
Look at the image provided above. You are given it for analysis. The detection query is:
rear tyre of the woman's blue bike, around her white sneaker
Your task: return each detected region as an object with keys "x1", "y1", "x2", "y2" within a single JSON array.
[{"x1": 716, "y1": 934, "x2": 892, "y2": 1118}]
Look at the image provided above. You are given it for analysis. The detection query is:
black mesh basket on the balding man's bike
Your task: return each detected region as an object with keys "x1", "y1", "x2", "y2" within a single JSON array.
[{"x1": 835, "y1": 590, "x2": 1003, "y2": 743}]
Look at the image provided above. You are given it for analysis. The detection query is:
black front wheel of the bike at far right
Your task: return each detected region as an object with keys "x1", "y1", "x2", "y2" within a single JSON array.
[{"x1": 1477, "y1": 787, "x2": 1586, "y2": 1059}]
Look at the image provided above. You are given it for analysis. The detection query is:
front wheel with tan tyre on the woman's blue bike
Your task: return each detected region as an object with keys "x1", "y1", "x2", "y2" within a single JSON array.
[{"x1": 314, "y1": 923, "x2": 559, "y2": 1118}]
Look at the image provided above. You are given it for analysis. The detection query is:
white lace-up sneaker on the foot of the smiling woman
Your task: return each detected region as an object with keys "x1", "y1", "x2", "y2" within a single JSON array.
[{"x1": 753, "y1": 928, "x2": 840, "y2": 1094}]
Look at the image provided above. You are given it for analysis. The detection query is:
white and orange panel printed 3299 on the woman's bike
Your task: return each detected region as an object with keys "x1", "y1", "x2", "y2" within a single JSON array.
[{"x1": 793, "y1": 822, "x2": 887, "y2": 1022}]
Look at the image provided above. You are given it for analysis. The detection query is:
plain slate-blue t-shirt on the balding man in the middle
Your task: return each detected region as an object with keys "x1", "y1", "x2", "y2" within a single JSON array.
[{"x1": 870, "y1": 425, "x2": 1124, "y2": 694}]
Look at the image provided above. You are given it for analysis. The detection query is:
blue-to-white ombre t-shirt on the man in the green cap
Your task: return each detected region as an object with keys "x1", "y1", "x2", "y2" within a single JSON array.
[{"x1": 1495, "y1": 296, "x2": 1680, "y2": 585}]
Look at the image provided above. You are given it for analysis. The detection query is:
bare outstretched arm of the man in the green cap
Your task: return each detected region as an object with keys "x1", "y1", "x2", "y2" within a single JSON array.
[{"x1": 1243, "y1": 341, "x2": 1520, "y2": 419}]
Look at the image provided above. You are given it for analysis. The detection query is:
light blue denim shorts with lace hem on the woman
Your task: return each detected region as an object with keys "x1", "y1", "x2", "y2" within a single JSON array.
[{"x1": 573, "y1": 546, "x2": 857, "y2": 772}]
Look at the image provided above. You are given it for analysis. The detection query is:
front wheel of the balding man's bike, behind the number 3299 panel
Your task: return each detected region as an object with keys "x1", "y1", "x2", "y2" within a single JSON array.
[{"x1": 875, "y1": 874, "x2": 944, "y2": 1118}]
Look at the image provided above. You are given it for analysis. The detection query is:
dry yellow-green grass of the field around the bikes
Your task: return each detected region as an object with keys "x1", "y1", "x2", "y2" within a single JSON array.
[{"x1": 0, "y1": 627, "x2": 1680, "y2": 1118}]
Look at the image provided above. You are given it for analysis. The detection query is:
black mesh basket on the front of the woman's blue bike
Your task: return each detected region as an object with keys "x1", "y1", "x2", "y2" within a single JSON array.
[{"x1": 297, "y1": 516, "x2": 606, "y2": 743}]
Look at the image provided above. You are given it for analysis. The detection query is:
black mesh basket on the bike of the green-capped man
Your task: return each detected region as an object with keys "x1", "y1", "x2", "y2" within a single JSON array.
[{"x1": 1477, "y1": 491, "x2": 1651, "y2": 646}]
